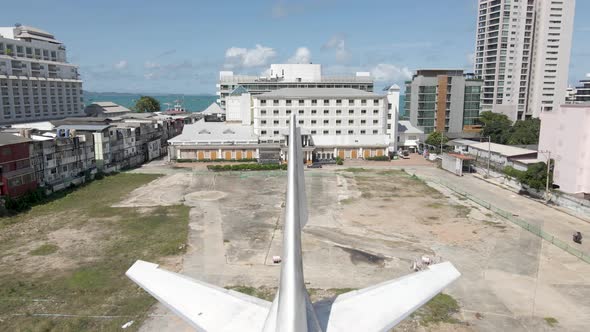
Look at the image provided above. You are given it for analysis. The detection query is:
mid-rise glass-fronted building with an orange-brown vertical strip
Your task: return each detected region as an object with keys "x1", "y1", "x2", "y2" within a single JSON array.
[{"x1": 404, "y1": 69, "x2": 483, "y2": 138}]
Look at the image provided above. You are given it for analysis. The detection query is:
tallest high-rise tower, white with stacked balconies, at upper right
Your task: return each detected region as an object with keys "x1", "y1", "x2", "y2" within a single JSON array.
[{"x1": 475, "y1": 0, "x2": 575, "y2": 120}]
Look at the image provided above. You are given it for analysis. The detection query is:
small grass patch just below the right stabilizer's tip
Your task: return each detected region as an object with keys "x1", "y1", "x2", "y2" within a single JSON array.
[{"x1": 416, "y1": 293, "x2": 459, "y2": 326}]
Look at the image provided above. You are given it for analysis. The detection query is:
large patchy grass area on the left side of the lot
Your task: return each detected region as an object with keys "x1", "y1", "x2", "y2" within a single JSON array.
[{"x1": 0, "y1": 173, "x2": 189, "y2": 331}]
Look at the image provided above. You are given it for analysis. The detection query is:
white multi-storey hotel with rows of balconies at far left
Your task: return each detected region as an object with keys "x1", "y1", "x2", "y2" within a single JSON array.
[{"x1": 0, "y1": 25, "x2": 84, "y2": 125}]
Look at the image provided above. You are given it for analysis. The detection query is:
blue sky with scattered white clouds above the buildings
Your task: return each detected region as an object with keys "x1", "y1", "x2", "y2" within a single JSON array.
[{"x1": 0, "y1": 0, "x2": 590, "y2": 94}]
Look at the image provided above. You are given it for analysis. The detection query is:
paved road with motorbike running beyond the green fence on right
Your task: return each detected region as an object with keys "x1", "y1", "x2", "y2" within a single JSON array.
[{"x1": 406, "y1": 167, "x2": 590, "y2": 256}]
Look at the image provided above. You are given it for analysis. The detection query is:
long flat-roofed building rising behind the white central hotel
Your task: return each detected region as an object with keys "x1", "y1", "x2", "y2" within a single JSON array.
[{"x1": 217, "y1": 64, "x2": 373, "y2": 109}]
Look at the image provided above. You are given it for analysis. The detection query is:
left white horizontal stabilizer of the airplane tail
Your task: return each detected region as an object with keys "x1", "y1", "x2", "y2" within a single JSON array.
[{"x1": 126, "y1": 260, "x2": 271, "y2": 332}]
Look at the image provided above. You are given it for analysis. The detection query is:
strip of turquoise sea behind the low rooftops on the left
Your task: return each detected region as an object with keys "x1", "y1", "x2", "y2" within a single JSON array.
[{"x1": 84, "y1": 91, "x2": 217, "y2": 112}]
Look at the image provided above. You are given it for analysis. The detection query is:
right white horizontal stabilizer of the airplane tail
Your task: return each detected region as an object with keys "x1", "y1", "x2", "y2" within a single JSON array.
[{"x1": 316, "y1": 262, "x2": 461, "y2": 332}]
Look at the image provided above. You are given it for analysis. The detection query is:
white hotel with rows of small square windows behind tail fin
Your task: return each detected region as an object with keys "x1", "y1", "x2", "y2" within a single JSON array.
[{"x1": 253, "y1": 88, "x2": 395, "y2": 161}]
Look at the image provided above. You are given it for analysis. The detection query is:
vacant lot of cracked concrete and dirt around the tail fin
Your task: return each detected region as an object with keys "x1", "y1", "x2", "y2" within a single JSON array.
[{"x1": 121, "y1": 168, "x2": 590, "y2": 331}]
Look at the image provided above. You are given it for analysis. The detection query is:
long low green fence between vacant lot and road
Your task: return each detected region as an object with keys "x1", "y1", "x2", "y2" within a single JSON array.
[{"x1": 438, "y1": 180, "x2": 590, "y2": 264}]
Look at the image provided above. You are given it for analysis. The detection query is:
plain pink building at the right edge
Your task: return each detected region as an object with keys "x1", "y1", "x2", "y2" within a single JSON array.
[{"x1": 539, "y1": 104, "x2": 590, "y2": 194}]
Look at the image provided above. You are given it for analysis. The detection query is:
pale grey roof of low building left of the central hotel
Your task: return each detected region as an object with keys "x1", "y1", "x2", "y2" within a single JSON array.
[{"x1": 168, "y1": 120, "x2": 258, "y2": 145}]
